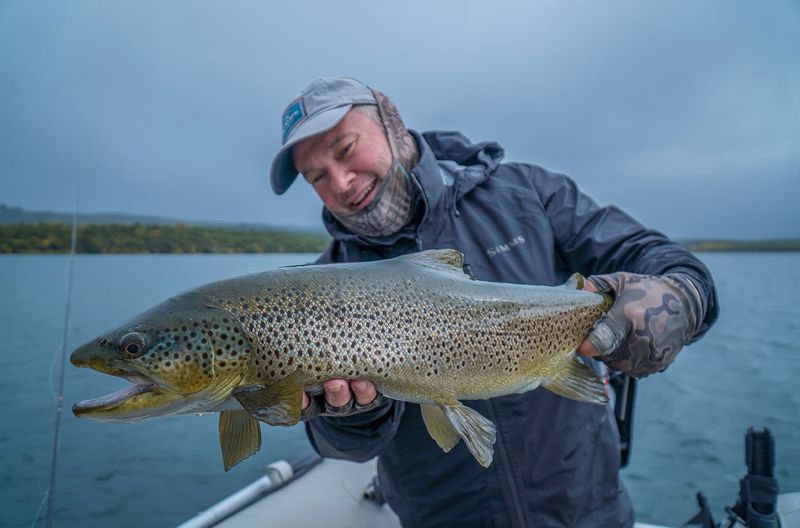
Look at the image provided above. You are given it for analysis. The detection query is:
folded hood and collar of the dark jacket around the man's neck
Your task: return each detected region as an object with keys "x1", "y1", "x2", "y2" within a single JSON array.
[{"x1": 322, "y1": 129, "x2": 504, "y2": 246}]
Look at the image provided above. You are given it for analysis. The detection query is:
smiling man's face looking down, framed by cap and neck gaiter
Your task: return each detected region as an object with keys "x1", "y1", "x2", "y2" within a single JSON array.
[{"x1": 292, "y1": 110, "x2": 392, "y2": 216}]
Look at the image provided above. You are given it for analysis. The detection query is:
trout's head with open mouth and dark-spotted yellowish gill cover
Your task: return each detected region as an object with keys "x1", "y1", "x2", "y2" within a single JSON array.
[{"x1": 70, "y1": 295, "x2": 251, "y2": 421}]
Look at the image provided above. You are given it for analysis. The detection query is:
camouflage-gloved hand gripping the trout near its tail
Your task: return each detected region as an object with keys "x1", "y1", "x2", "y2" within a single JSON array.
[{"x1": 588, "y1": 272, "x2": 705, "y2": 377}]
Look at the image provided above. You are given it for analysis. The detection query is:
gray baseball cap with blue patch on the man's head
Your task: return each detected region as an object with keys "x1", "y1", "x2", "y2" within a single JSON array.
[{"x1": 269, "y1": 77, "x2": 378, "y2": 194}]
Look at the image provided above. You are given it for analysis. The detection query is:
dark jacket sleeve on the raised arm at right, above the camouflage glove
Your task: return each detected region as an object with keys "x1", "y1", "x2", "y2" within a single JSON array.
[{"x1": 530, "y1": 166, "x2": 719, "y2": 343}]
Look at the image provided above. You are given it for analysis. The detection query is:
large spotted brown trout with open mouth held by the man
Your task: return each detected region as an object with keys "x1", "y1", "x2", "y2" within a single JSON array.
[{"x1": 71, "y1": 250, "x2": 609, "y2": 470}]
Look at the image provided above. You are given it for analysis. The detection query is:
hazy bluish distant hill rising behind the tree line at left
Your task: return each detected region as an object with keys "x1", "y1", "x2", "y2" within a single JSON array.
[{"x1": 0, "y1": 203, "x2": 324, "y2": 233}]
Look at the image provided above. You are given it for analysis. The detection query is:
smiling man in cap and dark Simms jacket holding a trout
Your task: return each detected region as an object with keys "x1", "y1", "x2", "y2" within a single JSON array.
[{"x1": 270, "y1": 78, "x2": 718, "y2": 527}]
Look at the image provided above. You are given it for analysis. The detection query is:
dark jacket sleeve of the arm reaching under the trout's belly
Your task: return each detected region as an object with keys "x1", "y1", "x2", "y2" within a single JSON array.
[{"x1": 306, "y1": 241, "x2": 404, "y2": 462}]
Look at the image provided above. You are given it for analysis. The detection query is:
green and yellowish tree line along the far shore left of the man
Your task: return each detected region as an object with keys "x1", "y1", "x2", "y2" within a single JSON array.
[{"x1": 0, "y1": 222, "x2": 330, "y2": 253}]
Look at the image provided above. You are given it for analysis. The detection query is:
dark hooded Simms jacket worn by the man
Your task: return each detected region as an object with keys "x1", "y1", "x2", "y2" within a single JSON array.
[{"x1": 308, "y1": 132, "x2": 718, "y2": 527}]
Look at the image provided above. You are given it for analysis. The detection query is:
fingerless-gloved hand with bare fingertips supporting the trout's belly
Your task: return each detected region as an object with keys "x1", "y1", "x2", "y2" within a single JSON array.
[{"x1": 300, "y1": 379, "x2": 383, "y2": 420}]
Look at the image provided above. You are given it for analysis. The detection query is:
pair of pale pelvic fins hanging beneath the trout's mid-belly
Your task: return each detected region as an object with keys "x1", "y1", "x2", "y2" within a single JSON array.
[{"x1": 421, "y1": 401, "x2": 496, "y2": 467}]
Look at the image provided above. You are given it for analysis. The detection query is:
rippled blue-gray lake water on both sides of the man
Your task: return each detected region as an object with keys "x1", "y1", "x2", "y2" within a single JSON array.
[{"x1": 0, "y1": 253, "x2": 800, "y2": 528}]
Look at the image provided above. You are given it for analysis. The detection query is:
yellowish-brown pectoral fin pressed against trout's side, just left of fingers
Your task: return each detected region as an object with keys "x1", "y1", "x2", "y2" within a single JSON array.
[{"x1": 233, "y1": 371, "x2": 303, "y2": 425}]
